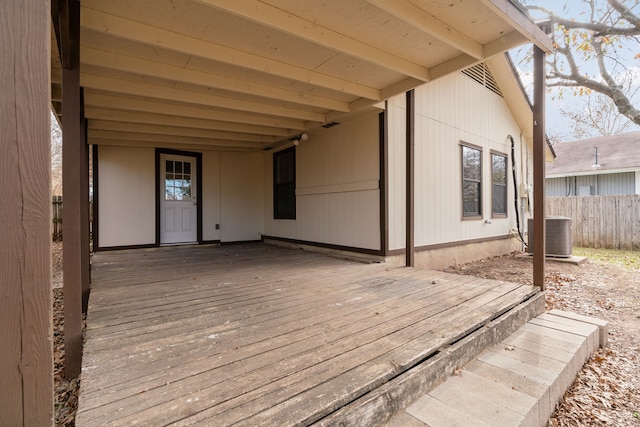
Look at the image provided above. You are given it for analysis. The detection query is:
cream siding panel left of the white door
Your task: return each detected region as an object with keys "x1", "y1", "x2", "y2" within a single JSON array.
[{"x1": 98, "y1": 146, "x2": 156, "y2": 247}]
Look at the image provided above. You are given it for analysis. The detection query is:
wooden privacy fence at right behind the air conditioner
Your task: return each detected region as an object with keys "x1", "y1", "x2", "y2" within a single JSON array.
[{"x1": 546, "y1": 194, "x2": 640, "y2": 250}]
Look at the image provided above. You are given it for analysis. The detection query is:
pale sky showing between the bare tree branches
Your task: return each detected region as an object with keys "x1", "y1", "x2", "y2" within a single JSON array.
[{"x1": 510, "y1": 0, "x2": 640, "y2": 141}]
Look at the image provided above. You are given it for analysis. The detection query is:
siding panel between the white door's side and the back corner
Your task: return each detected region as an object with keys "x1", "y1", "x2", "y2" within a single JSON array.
[{"x1": 220, "y1": 152, "x2": 264, "y2": 242}]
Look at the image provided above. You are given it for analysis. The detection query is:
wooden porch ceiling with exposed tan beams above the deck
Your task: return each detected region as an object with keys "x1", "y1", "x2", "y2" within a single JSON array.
[{"x1": 51, "y1": 0, "x2": 550, "y2": 150}]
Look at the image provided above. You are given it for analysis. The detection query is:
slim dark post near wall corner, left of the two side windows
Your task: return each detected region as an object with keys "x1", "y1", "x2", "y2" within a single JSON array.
[{"x1": 405, "y1": 89, "x2": 416, "y2": 267}]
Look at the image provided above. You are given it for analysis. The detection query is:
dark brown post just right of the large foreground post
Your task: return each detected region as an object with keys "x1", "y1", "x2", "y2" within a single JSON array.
[{"x1": 59, "y1": 0, "x2": 83, "y2": 379}]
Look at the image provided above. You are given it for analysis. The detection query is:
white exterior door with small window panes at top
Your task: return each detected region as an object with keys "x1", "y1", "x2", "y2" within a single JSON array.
[{"x1": 159, "y1": 154, "x2": 198, "y2": 245}]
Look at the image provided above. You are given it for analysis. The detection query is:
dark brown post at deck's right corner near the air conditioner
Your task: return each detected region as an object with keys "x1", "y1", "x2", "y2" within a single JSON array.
[{"x1": 533, "y1": 46, "x2": 546, "y2": 291}]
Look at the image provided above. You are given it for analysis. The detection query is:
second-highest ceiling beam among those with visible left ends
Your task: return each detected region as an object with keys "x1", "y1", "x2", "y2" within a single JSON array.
[{"x1": 80, "y1": 46, "x2": 349, "y2": 112}]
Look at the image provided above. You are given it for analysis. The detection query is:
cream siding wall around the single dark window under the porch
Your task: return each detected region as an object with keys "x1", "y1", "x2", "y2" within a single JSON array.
[{"x1": 264, "y1": 113, "x2": 380, "y2": 249}]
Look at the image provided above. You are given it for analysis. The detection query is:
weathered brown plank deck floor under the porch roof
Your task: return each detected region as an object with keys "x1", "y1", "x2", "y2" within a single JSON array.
[{"x1": 76, "y1": 244, "x2": 536, "y2": 426}]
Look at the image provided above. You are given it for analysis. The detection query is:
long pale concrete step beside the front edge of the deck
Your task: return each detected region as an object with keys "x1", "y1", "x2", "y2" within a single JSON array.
[{"x1": 388, "y1": 310, "x2": 608, "y2": 427}]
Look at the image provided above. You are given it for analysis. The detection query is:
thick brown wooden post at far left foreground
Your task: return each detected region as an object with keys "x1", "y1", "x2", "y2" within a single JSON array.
[{"x1": 0, "y1": 0, "x2": 53, "y2": 426}]
